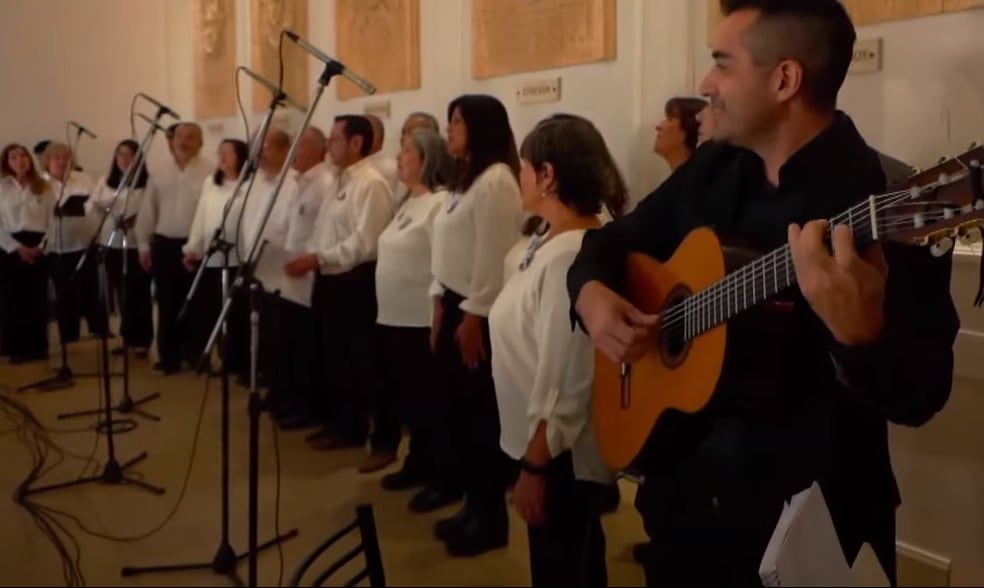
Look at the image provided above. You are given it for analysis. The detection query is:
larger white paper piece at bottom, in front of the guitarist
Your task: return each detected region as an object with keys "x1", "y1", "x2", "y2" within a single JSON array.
[{"x1": 759, "y1": 482, "x2": 853, "y2": 586}]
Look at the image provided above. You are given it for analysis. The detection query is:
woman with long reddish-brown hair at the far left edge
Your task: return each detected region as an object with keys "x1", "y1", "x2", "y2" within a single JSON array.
[{"x1": 0, "y1": 144, "x2": 55, "y2": 363}]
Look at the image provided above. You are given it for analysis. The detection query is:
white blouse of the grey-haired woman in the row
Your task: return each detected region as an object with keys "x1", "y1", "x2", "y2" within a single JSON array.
[{"x1": 376, "y1": 190, "x2": 448, "y2": 327}]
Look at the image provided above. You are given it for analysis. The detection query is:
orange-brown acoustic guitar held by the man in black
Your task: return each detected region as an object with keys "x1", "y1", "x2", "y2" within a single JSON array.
[{"x1": 592, "y1": 144, "x2": 984, "y2": 470}]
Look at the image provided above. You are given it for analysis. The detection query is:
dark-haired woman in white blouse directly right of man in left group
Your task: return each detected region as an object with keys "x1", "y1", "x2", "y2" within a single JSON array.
[{"x1": 182, "y1": 139, "x2": 249, "y2": 378}]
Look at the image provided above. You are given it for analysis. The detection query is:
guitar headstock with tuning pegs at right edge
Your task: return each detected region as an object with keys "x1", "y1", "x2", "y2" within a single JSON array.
[{"x1": 872, "y1": 143, "x2": 984, "y2": 255}]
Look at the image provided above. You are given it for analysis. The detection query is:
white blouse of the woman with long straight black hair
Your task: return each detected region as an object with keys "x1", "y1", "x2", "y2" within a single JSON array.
[{"x1": 430, "y1": 163, "x2": 523, "y2": 316}]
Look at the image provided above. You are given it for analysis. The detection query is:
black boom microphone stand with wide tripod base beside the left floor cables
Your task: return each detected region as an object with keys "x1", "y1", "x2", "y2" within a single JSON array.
[{"x1": 23, "y1": 110, "x2": 171, "y2": 496}]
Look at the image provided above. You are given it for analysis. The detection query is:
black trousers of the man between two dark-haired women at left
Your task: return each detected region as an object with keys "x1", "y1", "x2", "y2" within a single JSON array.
[{"x1": 150, "y1": 235, "x2": 193, "y2": 367}]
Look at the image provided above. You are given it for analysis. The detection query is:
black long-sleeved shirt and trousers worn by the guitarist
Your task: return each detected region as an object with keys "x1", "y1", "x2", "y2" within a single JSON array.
[{"x1": 568, "y1": 113, "x2": 959, "y2": 578}]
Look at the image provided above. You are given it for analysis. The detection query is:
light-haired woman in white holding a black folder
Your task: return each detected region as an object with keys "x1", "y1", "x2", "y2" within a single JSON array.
[{"x1": 41, "y1": 143, "x2": 109, "y2": 343}]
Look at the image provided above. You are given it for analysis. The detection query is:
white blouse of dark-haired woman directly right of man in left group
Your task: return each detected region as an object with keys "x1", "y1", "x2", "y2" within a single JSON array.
[{"x1": 181, "y1": 176, "x2": 242, "y2": 268}]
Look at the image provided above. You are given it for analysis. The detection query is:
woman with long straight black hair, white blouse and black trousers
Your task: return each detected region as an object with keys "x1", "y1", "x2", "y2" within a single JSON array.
[{"x1": 428, "y1": 95, "x2": 522, "y2": 556}]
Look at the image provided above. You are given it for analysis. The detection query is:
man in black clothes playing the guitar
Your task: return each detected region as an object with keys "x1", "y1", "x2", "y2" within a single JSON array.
[{"x1": 568, "y1": 0, "x2": 959, "y2": 585}]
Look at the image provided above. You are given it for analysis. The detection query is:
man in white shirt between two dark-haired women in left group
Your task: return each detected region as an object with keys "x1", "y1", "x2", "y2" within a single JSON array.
[{"x1": 136, "y1": 123, "x2": 215, "y2": 375}]
